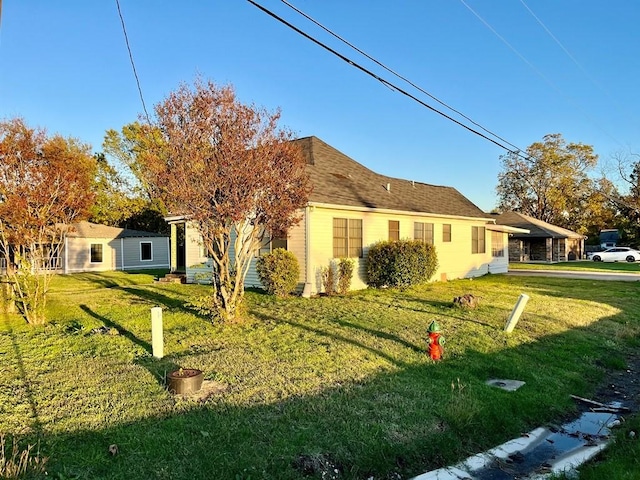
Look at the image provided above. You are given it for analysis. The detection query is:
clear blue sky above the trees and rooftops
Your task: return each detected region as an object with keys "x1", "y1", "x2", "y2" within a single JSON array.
[{"x1": 0, "y1": 0, "x2": 640, "y2": 210}]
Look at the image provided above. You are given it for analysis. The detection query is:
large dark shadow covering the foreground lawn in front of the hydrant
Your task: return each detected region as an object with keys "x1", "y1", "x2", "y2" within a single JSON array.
[{"x1": 16, "y1": 274, "x2": 638, "y2": 480}]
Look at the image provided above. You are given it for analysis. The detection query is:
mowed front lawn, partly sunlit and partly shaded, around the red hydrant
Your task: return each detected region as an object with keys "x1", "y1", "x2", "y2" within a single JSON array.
[{"x1": 0, "y1": 272, "x2": 640, "y2": 480}]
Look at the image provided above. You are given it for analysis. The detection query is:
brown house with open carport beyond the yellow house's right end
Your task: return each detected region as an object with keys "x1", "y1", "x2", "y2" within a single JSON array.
[{"x1": 494, "y1": 212, "x2": 586, "y2": 262}]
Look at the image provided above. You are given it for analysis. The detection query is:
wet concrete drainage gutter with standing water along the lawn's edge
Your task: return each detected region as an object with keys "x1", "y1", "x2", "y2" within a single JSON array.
[{"x1": 413, "y1": 380, "x2": 622, "y2": 480}]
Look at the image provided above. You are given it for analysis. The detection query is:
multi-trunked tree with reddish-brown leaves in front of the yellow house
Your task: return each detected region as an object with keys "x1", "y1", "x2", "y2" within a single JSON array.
[{"x1": 138, "y1": 79, "x2": 310, "y2": 319}]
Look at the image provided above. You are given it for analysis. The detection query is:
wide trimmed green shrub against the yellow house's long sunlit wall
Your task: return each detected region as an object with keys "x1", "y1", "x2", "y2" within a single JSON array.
[{"x1": 367, "y1": 240, "x2": 438, "y2": 288}]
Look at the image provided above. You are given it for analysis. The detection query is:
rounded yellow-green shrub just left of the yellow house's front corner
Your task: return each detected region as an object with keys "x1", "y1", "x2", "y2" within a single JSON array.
[{"x1": 256, "y1": 248, "x2": 300, "y2": 297}]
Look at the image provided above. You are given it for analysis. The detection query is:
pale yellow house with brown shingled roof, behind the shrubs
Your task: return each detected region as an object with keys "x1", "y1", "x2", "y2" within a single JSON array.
[{"x1": 167, "y1": 137, "x2": 524, "y2": 296}]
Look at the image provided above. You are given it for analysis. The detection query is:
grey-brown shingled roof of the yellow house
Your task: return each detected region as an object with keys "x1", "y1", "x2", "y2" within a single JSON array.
[{"x1": 296, "y1": 137, "x2": 489, "y2": 218}]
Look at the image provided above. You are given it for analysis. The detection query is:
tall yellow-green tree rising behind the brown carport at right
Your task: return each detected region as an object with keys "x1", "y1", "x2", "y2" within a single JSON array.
[{"x1": 496, "y1": 134, "x2": 598, "y2": 230}]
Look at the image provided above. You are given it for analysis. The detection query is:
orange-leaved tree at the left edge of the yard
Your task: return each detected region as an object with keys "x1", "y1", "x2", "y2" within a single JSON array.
[{"x1": 0, "y1": 118, "x2": 95, "y2": 324}]
